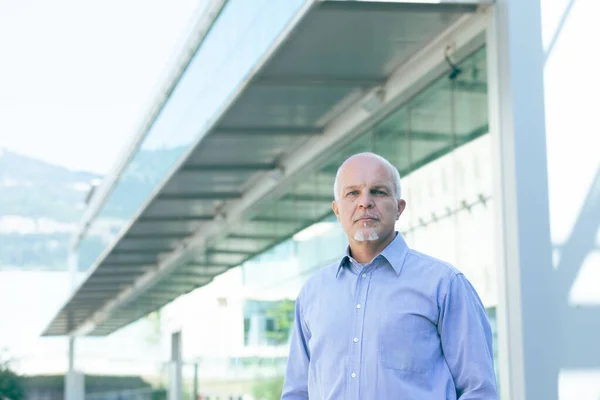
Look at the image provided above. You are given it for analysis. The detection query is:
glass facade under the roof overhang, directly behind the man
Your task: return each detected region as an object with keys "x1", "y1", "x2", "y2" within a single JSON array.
[{"x1": 165, "y1": 45, "x2": 497, "y2": 399}]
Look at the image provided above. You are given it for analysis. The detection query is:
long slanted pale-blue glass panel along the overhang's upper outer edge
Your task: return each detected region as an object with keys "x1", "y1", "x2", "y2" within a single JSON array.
[{"x1": 79, "y1": 0, "x2": 304, "y2": 270}]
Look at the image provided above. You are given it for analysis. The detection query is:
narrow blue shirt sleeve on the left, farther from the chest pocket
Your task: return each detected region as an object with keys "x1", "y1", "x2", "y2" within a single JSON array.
[{"x1": 281, "y1": 295, "x2": 310, "y2": 400}]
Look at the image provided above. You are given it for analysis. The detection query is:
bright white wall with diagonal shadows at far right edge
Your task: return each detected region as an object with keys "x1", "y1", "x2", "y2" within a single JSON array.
[{"x1": 540, "y1": 0, "x2": 600, "y2": 400}]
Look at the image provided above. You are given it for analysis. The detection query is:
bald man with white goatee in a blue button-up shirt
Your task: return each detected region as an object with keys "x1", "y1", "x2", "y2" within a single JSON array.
[{"x1": 282, "y1": 153, "x2": 497, "y2": 400}]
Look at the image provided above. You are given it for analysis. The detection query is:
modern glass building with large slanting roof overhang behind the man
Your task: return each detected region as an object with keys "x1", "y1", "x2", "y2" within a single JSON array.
[{"x1": 44, "y1": 0, "x2": 600, "y2": 399}]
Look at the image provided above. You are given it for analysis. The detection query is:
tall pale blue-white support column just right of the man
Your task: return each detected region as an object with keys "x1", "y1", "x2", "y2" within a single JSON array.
[{"x1": 487, "y1": 0, "x2": 558, "y2": 400}]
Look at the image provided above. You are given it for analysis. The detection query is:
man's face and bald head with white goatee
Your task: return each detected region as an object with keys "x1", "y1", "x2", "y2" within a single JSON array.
[{"x1": 333, "y1": 155, "x2": 405, "y2": 242}]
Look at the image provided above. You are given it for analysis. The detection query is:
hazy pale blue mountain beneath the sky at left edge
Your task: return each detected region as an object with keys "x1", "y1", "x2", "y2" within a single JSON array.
[{"x1": 0, "y1": 149, "x2": 101, "y2": 270}]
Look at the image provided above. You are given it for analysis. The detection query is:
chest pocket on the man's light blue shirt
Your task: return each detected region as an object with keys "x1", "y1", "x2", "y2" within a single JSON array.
[{"x1": 379, "y1": 312, "x2": 435, "y2": 372}]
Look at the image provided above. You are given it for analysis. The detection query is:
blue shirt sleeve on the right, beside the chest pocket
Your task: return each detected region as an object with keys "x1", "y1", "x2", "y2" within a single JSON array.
[{"x1": 438, "y1": 274, "x2": 498, "y2": 400}]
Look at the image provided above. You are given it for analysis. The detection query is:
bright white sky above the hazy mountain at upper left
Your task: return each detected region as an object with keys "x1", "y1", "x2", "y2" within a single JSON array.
[{"x1": 0, "y1": 0, "x2": 208, "y2": 174}]
